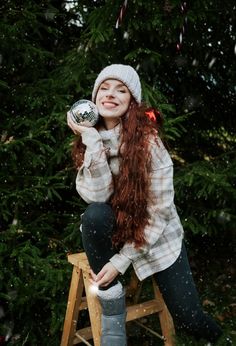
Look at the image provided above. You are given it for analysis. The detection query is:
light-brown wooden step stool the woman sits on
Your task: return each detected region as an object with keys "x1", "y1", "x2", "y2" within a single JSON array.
[{"x1": 61, "y1": 252, "x2": 174, "y2": 346}]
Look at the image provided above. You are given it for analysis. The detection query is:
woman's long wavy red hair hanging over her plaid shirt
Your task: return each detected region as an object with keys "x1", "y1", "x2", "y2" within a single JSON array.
[{"x1": 72, "y1": 100, "x2": 162, "y2": 248}]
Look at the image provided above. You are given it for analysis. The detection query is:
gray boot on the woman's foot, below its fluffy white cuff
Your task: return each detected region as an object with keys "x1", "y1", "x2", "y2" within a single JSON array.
[{"x1": 98, "y1": 292, "x2": 127, "y2": 346}]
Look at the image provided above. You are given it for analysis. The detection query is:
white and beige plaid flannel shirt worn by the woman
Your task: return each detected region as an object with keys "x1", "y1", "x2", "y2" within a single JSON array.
[{"x1": 76, "y1": 125, "x2": 183, "y2": 280}]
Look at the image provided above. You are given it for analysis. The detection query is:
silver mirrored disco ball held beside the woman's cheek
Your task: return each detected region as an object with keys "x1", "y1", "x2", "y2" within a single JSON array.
[{"x1": 70, "y1": 100, "x2": 99, "y2": 127}]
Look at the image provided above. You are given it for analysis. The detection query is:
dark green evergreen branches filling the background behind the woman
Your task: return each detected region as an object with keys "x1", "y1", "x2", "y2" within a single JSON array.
[{"x1": 0, "y1": 0, "x2": 236, "y2": 346}]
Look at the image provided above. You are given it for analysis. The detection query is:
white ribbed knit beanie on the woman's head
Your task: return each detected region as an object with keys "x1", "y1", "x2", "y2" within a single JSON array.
[{"x1": 92, "y1": 64, "x2": 142, "y2": 103}]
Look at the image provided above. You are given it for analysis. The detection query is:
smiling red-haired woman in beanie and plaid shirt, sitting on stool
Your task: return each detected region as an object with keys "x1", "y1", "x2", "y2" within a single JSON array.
[{"x1": 67, "y1": 64, "x2": 230, "y2": 346}]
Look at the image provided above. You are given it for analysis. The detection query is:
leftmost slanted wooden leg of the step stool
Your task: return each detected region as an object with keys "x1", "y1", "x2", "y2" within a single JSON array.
[{"x1": 61, "y1": 266, "x2": 83, "y2": 346}]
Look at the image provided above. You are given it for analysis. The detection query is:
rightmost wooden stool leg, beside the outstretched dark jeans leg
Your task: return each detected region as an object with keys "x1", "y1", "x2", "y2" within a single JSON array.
[{"x1": 152, "y1": 277, "x2": 175, "y2": 346}]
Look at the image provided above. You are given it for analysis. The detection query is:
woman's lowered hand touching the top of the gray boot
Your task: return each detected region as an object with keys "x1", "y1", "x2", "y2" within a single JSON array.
[{"x1": 91, "y1": 262, "x2": 119, "y2": 287}]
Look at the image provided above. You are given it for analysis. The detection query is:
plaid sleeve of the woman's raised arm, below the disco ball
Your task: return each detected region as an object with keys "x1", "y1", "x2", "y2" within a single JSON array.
[{"x1": 76, "y1": 128, "x2": 113, "y2": 203}]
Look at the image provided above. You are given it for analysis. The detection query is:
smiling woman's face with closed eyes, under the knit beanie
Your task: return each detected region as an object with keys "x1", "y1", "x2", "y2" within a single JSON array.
[{"x1": 96, "y1": 79, "x2": 131, "y2": 128}]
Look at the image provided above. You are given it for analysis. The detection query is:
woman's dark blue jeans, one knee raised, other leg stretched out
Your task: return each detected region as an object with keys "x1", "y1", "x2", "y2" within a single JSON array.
[{"x1": 82, "y1": 203, "x2": 222, "y2": 342}]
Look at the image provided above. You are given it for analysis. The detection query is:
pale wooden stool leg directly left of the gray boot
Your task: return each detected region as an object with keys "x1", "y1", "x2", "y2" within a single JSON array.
[{"x1": 83, "y1": 271, "x2": 101, "y2": 346}]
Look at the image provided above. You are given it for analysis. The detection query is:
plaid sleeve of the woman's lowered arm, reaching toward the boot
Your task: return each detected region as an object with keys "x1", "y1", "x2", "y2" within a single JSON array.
[{"x1": 110, "y1": 139, "x2": 176, "y2": 274}]
